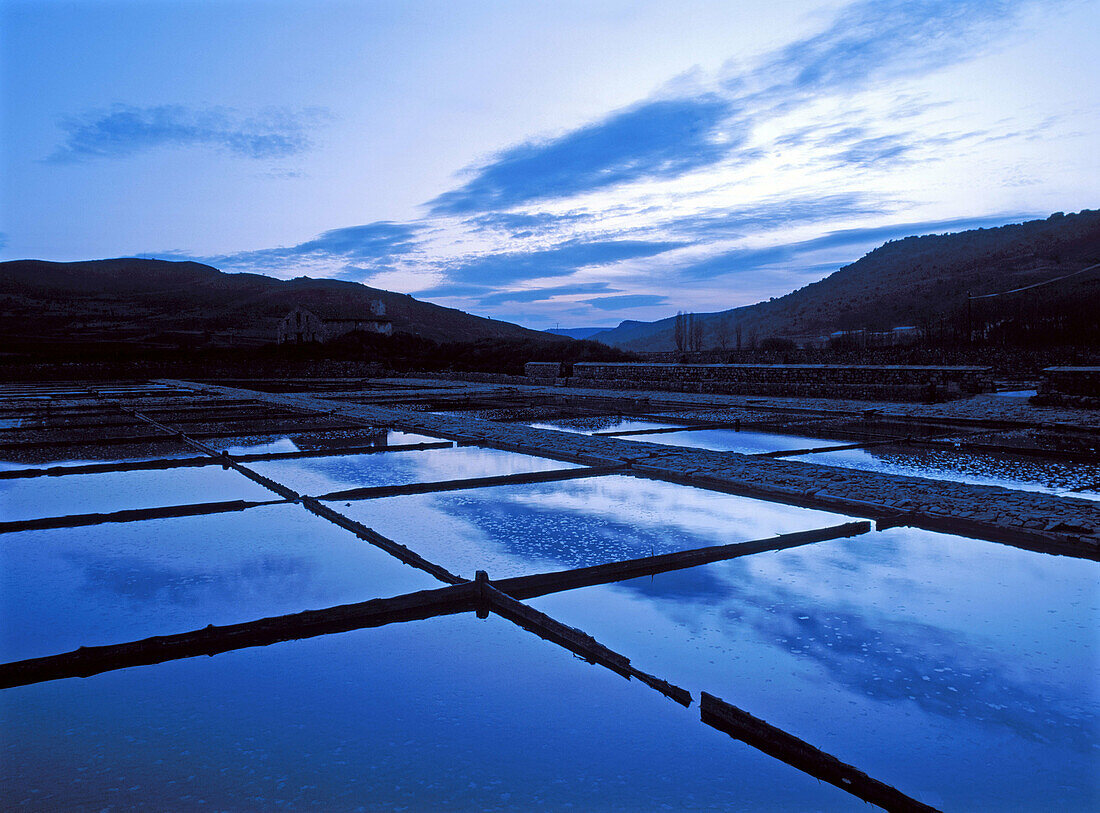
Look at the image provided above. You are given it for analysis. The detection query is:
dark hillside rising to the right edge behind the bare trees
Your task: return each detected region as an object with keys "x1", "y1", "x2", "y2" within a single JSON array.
[{"x1": 592, "y1": 210, "x2": 1100, "y2": 351}]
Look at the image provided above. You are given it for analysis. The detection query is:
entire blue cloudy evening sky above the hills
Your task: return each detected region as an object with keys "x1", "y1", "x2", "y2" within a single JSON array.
[{"x1": 0, "y1": 0, "x2": 1100, "y2": 329}]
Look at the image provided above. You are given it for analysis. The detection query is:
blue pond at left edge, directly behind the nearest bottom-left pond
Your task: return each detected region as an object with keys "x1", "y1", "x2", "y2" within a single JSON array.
[{"x1": 0, "y1": 506, "x2": 439, "y2": 661}]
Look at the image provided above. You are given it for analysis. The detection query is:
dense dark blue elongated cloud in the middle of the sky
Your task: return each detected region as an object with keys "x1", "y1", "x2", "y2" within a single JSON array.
[{"x1": 430, "y1": 95, "x2": 747, "y2": 215}]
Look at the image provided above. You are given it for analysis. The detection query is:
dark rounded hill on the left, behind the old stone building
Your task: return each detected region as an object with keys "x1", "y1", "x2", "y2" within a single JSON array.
[{"x1": 0, "y1": 259, "x2": 562, "y2": 348}]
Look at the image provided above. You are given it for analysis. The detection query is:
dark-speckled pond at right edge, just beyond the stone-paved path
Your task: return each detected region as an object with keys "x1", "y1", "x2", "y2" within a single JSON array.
[{"x1": 788, "y1": 447, "x2": 1100, "y2": 499}]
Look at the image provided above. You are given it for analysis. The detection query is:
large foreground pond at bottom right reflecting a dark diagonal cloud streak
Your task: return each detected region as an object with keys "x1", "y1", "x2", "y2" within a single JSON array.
[{"x1": 530, "y1": 529, "x2": 1100, "y2": 811}]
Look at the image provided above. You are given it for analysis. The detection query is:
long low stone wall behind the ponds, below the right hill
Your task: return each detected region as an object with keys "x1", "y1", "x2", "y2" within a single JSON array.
[{"x1": 568, "y1": 362, "x2": 992, "y2": 402}]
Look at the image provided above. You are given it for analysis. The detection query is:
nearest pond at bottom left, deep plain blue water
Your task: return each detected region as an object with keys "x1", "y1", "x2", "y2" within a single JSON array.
[{"x1": 0, "y1": 614, "x2": 866, "y2": 811}]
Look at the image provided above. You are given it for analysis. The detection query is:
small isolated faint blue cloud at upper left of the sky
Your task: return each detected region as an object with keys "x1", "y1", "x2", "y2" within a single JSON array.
[{"x1": 47, "y1": 105, "x2": 328, "y2": 163}]
